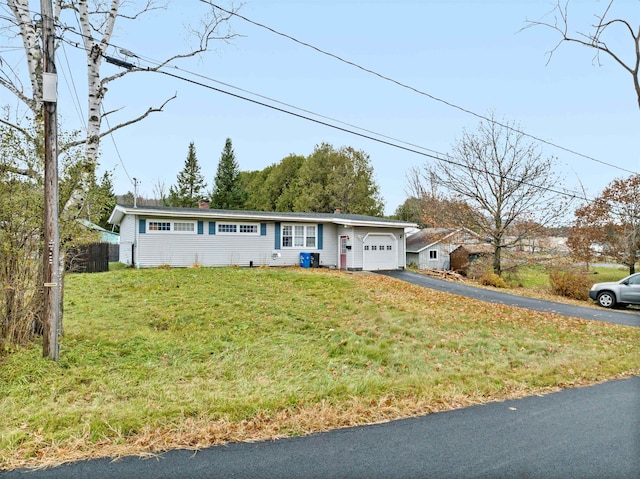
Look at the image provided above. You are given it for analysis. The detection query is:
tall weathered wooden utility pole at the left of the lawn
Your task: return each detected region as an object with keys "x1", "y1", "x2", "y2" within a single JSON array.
[{"x1": 40, "y1": 0, "x2": 61, "y2": 361}]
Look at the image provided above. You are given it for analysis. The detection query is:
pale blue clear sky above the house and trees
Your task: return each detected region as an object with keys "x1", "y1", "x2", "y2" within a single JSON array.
[{"x1": 0, "y1": 0, "x2": 640, "y2": 214}]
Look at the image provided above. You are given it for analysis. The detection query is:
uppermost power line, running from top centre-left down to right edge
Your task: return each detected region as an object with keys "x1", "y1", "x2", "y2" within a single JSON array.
[{"x1": 200, "y1": 0, "x2": 637, "y2": 174}]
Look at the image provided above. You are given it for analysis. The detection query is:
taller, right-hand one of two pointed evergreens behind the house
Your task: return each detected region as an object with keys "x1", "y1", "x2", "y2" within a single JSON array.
[{"x1": 211, "y1": 138, "x2": 247, "y2": 210}]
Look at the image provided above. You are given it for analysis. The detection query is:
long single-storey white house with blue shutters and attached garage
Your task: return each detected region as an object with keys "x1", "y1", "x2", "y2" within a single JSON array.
[{"x1": 109, "y1": 205, "x2": 416, "y2": 271}]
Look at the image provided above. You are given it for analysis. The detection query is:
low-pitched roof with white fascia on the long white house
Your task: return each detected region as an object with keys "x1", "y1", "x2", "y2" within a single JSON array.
[{"x1": 109, "y1": 205, "x2": 417, "y2": 228}]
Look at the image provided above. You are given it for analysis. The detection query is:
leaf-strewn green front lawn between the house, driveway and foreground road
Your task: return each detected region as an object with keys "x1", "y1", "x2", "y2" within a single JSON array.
[{"x1": 0, "y1": 268, "x2": 640, "y2": 469}]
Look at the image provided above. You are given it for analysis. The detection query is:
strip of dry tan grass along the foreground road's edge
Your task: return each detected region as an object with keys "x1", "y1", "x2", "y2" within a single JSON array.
[{"x1": 8, "y1": 371, "x2": 640, "y2": 469}]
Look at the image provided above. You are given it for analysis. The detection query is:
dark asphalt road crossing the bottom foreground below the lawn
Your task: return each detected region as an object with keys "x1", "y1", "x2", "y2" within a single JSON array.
[{"x1": 0, "y1": 377, "x2": 640, "y2": 479}]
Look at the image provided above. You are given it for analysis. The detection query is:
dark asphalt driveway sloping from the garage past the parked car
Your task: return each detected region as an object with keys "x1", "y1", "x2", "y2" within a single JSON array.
[{"x1": 380, "y1": 271, "x2": 640, "y2": 326}]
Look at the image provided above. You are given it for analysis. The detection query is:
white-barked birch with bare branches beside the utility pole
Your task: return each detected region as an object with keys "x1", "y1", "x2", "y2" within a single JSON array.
[{"x1": 0, "y1": 0, "x2": 235, "y2": 204}]
